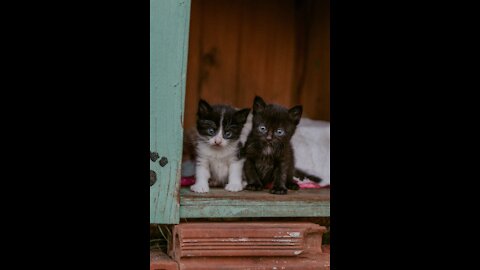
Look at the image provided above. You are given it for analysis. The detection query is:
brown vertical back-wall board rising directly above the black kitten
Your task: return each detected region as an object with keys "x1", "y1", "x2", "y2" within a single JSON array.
[{"x1": 237, "y1": 0, "x2": 295, "y2": 106}]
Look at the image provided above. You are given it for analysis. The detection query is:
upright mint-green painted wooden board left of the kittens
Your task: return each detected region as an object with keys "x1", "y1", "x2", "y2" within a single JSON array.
[{"x1": 150, "y1": 0, "x2": 190, "y2": 224}]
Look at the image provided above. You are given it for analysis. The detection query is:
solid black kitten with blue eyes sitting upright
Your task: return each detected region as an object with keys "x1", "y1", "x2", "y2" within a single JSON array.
[{"x1": 243, "y1": 96, "x2": 302, "y2": 194}]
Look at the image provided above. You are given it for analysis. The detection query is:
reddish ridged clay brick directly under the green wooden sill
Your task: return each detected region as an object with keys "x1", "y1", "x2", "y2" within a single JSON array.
[{"x1": 169, "y1": 222, "x2": 326, "y2": 262}]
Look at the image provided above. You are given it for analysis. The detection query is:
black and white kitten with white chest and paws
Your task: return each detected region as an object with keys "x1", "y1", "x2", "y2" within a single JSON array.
[{"x1": 190, "y1": 99, "x2": 250, "y2": 193}]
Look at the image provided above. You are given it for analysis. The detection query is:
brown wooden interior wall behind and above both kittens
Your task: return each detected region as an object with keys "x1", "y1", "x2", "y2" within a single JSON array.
[{"x1": 184, "y1": 0, "x2": 330, "y2": 128}]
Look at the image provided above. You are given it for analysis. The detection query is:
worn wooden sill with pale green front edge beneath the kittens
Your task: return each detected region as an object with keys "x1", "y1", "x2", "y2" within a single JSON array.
[{"x1": 180, "y1": 188, "x2": 330, "y2": 218}]
